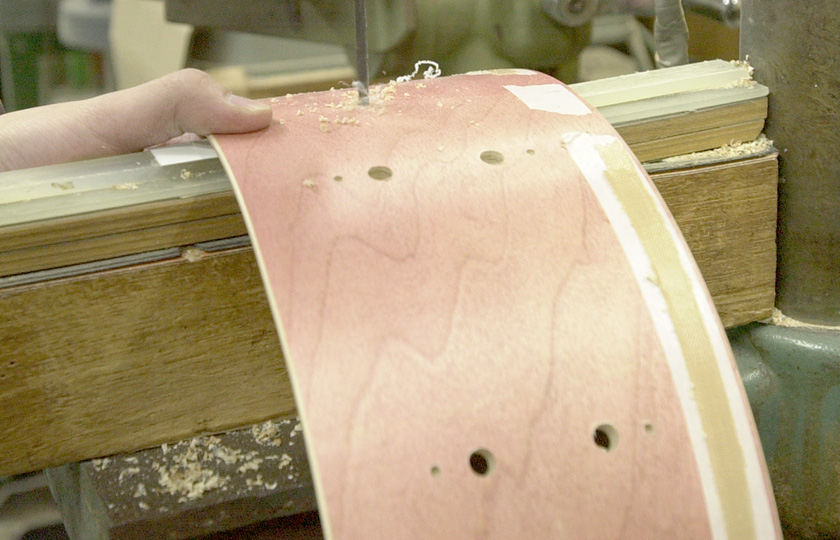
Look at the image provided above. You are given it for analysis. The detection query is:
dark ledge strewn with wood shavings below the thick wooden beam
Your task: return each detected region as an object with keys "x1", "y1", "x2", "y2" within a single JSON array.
[{"x1": 46, "y1": 418, "x2": 315, "y2": 540}]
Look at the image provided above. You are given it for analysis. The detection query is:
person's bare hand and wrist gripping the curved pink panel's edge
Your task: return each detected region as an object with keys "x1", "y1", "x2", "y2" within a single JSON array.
[{"x1": 0, "y1": 69, "x2": 271, "y2": 171}]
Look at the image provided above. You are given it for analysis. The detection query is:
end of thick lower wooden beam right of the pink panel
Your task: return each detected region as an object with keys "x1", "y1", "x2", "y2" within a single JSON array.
[{"x1": 651, "y1": 153, "x2": 778, "y2": 327}]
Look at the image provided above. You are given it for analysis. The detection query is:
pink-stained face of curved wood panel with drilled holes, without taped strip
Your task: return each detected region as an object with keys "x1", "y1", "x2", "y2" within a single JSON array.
[{"x1": 215, "y1": 72, "x2": 777, "y2": 539}]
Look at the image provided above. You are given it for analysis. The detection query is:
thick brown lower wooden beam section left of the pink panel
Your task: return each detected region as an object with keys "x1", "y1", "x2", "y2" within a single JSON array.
[{"x1": 0, "y1": 250, "x2": 294, "y2": 475}]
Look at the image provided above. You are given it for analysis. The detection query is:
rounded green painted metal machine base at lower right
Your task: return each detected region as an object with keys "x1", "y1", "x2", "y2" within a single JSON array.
[{"x1": 729, "y1": 324, "x2": 840, "y2": 540}]
